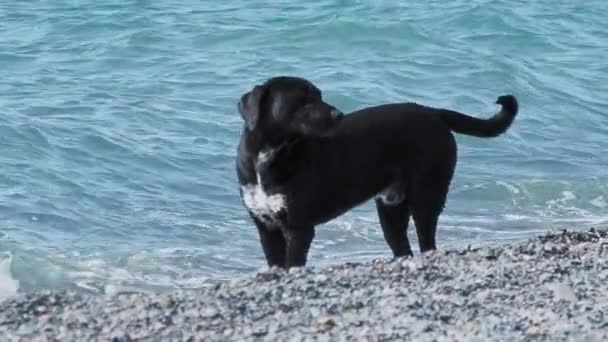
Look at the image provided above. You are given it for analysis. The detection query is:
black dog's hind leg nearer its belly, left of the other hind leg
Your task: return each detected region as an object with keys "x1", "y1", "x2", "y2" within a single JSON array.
[{"x1": 376, "y1": 198, "x2": 412, "y2": 257}]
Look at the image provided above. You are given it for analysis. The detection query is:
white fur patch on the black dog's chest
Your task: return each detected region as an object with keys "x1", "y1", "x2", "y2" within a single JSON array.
[{"x1": 241, "y1": 152, "x2": 286, "y2": 229}]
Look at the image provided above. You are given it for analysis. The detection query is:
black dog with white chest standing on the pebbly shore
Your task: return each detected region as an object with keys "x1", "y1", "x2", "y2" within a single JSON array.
[{"x1": 237, "y1": 77, "x2": 518, "y2": 268}]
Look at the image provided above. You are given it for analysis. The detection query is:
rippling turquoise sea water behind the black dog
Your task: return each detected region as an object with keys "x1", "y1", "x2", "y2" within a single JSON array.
[{"x1": 0, "y1": 0, "x2": 608, "y2": 295}]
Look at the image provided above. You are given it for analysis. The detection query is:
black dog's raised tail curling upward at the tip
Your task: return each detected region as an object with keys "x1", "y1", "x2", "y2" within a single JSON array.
[{"x1": 439, "y1": 95, "x2": 519, "y2": 138}]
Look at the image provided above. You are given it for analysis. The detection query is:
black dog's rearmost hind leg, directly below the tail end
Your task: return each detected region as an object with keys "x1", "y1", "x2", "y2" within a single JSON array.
[{"x1": 409, "y1": 168, "x2": 452, "y2": 253}]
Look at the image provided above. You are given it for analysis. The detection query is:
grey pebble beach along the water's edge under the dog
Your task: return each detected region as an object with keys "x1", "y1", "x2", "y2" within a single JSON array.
[{"x1": 0, "y1": 229, "x2": 608, "y2": 341}]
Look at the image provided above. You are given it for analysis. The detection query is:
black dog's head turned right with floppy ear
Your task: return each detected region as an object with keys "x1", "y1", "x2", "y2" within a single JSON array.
[{"x1": 238, "y1": 76, "x2": 342, "y2": 136}]
